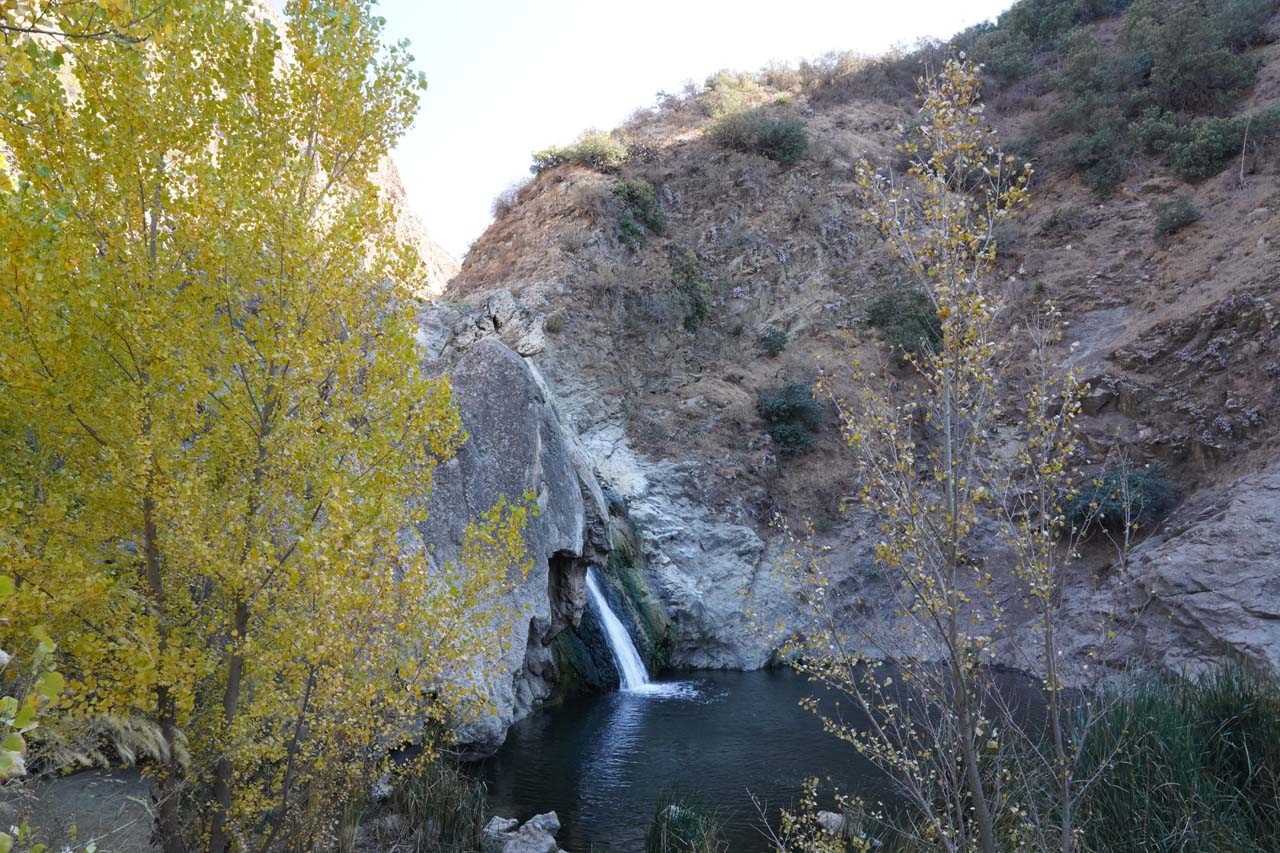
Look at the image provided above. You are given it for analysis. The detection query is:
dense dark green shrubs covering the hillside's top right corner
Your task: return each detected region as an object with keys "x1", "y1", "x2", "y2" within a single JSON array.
[{"x1": 1013, "y1": 0, "x2": 1280, "y2": 188}]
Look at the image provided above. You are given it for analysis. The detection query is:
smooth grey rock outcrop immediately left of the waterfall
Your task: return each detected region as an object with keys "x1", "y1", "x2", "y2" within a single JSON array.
[{"x1": 421, "y1": 338, "x2": 608, "y2": 753}]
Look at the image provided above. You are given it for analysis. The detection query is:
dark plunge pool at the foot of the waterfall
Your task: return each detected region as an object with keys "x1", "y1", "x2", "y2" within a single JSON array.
[{"x1": 477, "y1": 670, "x2": 892, "y2": 853}]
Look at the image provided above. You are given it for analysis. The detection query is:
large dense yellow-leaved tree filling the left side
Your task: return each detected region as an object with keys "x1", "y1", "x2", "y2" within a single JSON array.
[{"x1": 0, "y1": 0, "x2": 527, "y2": 853}]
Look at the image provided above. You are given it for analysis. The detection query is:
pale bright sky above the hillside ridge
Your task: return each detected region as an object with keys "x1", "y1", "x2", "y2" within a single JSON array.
[{"x1": 378, "y1": 0, "x2": 1011, "y2": 259}]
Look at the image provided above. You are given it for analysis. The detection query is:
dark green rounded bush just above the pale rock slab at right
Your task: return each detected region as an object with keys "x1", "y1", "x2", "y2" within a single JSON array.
[{"x1": 1062, "y1": 465, "x2": 1180, "y2": 530}]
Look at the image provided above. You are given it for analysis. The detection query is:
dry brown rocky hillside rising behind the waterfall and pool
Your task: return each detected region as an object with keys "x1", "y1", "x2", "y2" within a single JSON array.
[{"x1": 429, "y1": 0, "x2": 1280, "y2": 717}]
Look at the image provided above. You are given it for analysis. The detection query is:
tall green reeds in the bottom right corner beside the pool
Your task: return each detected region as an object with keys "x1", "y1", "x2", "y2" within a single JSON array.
[{"x1": 1080, "y1": 669, "x2": 1280, "y2": 853}]
